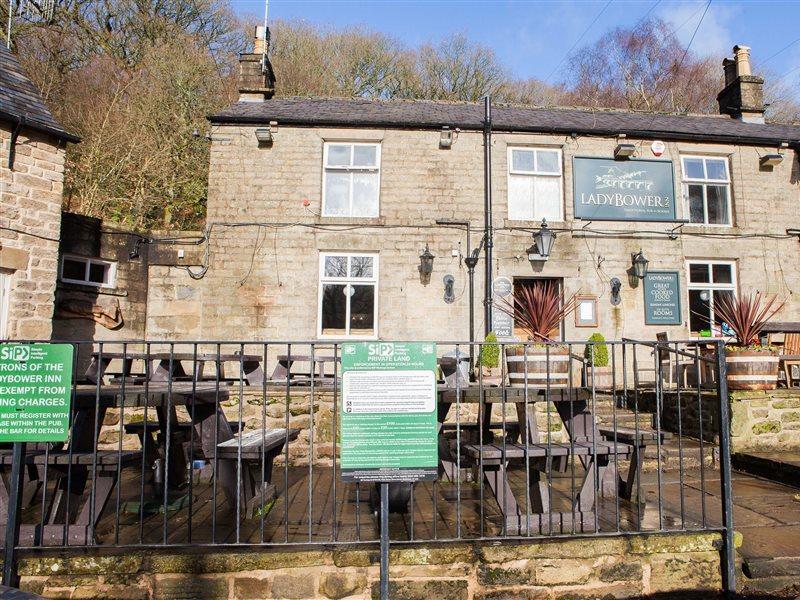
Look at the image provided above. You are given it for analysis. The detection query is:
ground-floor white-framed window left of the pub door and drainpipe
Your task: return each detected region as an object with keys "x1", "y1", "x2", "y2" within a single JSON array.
[{"x1": 318, "y1": 252, "x2": 378, "y2": 339}]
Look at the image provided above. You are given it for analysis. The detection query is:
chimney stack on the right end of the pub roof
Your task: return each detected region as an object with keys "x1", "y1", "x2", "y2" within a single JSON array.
[{"x1": 717, "y1": 46, "x2": 764, "y2": 123}]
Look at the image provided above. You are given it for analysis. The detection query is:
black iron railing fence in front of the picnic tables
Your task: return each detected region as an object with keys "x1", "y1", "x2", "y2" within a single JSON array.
[{"x1": 0, "y1": 340, "x2": 733, "y2": 592}]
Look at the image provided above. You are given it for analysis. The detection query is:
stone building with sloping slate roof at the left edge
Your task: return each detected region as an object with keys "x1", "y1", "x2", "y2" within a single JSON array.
[{"x1": 0, "y1": 46, "x2": 79, "y2": 340}]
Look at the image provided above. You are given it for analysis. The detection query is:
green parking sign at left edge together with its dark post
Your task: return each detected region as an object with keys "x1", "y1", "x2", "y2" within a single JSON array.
[{"x1": 0, "y1": 344, "x2": 73, "y2": 587}]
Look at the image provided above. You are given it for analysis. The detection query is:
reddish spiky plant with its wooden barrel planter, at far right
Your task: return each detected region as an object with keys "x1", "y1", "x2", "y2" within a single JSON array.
[{"x1": 714, "y1": 292, "x2": 784, "y2": 390}]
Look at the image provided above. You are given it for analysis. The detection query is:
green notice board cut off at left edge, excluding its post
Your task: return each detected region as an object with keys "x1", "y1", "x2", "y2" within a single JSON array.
[{"x1": 0, "y1": 344, "x2": 72, "y2": 442}]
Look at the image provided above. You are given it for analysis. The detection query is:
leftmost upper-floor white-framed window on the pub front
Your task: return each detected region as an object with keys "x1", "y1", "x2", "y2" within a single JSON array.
[{"x1": 322, "y1": 142, "x2": 381, "y2": 217}]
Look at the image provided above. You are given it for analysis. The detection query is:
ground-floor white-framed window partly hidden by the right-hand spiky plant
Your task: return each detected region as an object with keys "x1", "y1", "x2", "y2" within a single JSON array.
[{"x1": 686, "y1": 260, "x2": 737, "y2": 336}]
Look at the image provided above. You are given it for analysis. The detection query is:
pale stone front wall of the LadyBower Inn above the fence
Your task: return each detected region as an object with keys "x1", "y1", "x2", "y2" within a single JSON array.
[{"x1": 147, "y1": 126, "x2": 800, "y2": 340}]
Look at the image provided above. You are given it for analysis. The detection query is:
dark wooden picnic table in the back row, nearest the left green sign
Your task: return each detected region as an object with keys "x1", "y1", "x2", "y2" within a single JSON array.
[{"x1": 86, "y1": 351, "x2": 264, "y2": 385}]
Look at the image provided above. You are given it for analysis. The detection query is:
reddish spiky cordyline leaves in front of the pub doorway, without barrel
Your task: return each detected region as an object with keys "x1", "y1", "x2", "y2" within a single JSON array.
[{"x1": 497, "y1": 281, "x2": 577, "y2": 342}]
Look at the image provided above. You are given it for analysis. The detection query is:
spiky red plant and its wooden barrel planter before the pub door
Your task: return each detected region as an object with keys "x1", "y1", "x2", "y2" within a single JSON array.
[{"x1": 498, "y1": 281, "x2": 577, "y2": 388}]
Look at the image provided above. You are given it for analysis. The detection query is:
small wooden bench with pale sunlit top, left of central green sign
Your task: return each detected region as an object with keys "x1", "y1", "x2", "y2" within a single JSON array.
[{"x1": 216, "y1": 429, "x2": 300, "y2": 517}]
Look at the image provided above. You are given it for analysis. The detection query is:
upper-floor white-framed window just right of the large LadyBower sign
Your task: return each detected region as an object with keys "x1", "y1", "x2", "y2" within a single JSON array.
[{"x1": 681, "y1": 156, "x2": 733, "y2": 227}]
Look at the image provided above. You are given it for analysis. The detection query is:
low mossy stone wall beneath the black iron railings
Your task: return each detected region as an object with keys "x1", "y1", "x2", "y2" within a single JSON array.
[{"x1": 19, "y1": 534, "x2": 721, "y2": 600}]
